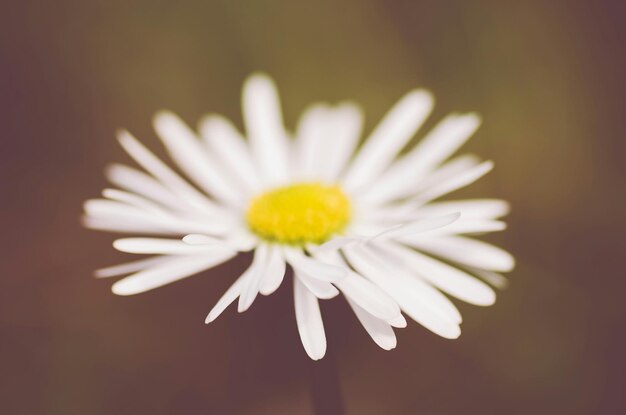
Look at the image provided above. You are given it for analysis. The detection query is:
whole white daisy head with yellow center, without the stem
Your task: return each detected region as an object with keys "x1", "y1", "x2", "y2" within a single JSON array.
[{"x1": 83, "y1": 74, "x2": 514, "y2": 360}]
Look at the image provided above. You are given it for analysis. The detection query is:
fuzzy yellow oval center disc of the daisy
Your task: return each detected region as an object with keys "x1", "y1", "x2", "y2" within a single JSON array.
[{"x1": 246, "y1": 183, "x2": 350, "y2": 244}]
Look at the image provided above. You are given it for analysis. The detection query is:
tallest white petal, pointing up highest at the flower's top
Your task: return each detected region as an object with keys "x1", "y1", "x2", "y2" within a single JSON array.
[{"x1": 242, "y1": 74, "x2": 290, "y2": 185}]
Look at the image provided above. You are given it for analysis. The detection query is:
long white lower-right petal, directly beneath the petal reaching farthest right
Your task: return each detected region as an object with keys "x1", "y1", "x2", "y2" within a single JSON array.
[{"x1": 383, "y1": 243, "x2": 496, "y2": 306}]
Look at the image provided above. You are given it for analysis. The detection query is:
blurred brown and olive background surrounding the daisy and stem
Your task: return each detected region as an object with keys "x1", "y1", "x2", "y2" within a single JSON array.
[{"x1": 0, "y1": 0, "x2": 626, "y2": 415}]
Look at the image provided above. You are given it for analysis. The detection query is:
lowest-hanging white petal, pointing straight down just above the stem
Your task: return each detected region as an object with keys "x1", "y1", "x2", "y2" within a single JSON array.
[{"x1": 293, "y1": 278, "x2": 326, "y2": 360}]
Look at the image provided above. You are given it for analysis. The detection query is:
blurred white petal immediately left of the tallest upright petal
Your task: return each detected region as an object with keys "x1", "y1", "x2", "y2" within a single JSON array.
[{"x1": 200, "y1": 115, "x2": 261, "y2": 192}]
